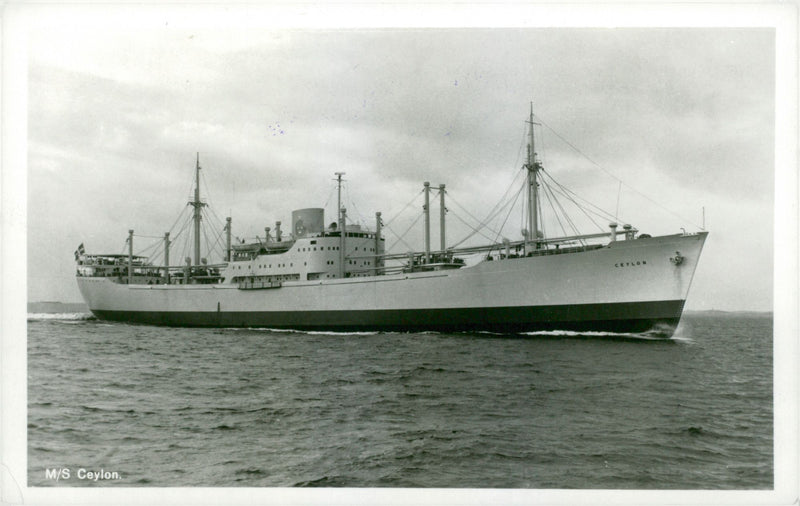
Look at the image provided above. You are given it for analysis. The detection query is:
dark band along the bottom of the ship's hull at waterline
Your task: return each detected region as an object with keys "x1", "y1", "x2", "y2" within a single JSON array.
[{"x1": 92, "y1": 300, "x2": 684, "y2": 337}]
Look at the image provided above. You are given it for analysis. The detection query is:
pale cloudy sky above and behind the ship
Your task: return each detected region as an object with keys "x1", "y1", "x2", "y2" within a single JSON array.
[{"x1": 20, "y1": 3, "x2": 775, "y2": 310}]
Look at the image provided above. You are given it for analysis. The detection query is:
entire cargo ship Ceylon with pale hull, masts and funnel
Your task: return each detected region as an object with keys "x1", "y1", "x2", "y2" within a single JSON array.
[{"x1": 75, "y1": 106, "x2": 707, "y2": 337}]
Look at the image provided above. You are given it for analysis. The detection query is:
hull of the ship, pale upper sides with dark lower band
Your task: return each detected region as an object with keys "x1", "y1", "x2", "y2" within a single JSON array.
[{"x1": 78, "y1": 233, "x2": 706, "y2": 337}]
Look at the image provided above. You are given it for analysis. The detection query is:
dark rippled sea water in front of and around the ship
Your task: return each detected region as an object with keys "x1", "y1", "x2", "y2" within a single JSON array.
[{"x1": 28, "y1": 313, "x2": 773, "y2": 489}]
